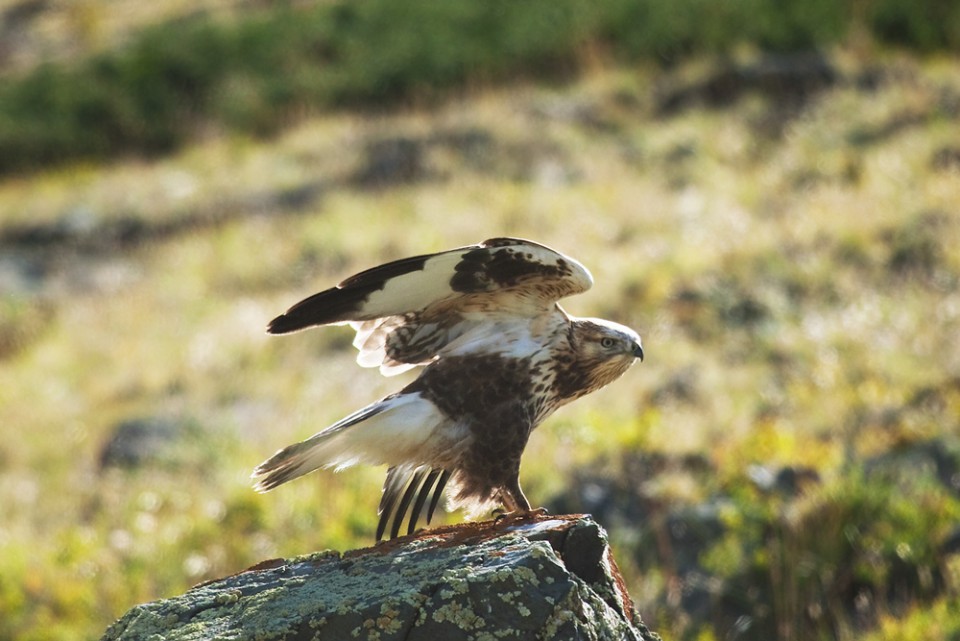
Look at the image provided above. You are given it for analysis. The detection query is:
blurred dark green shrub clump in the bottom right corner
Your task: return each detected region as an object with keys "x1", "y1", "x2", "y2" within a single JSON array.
[{"x1": 701, "y1": 458, "x2": 960, "y2": 639}]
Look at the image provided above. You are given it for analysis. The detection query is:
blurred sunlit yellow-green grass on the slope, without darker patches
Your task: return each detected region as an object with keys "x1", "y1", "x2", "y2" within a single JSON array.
[{"x1": 0, "y1": 56, "x2": 960, "y2": 639}]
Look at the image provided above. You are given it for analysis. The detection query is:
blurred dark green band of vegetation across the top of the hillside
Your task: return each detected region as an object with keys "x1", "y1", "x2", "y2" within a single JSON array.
[{"x1": 0, "y1": 0, "x2": 960, "y2": 173}]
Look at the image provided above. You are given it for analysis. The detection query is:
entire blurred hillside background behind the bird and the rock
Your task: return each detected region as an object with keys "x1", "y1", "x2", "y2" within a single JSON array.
[{"x1": 0, "y1": 0, "x2": 960, "y2": 641}]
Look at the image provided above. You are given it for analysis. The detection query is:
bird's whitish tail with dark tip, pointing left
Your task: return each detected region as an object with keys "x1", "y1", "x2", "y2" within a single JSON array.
[{"x1": 251, "y1": 393, "x2": 440, "y2": 492}]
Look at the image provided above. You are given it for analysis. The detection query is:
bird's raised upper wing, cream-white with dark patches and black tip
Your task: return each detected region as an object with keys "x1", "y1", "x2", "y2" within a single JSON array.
[{"x1": 267, "y1": 238, "x2": 593, "y2": 375}]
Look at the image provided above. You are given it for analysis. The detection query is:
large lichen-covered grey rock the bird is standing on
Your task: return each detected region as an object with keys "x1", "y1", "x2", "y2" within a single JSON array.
[{"x1": 104, "y1": 516, "x2": 658, "y2": 641}]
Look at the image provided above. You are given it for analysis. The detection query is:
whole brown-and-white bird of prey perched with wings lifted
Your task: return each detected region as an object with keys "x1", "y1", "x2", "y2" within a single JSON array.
[{"x1": 253, "y1": 238, "x2": 643, "y2": 541}]
